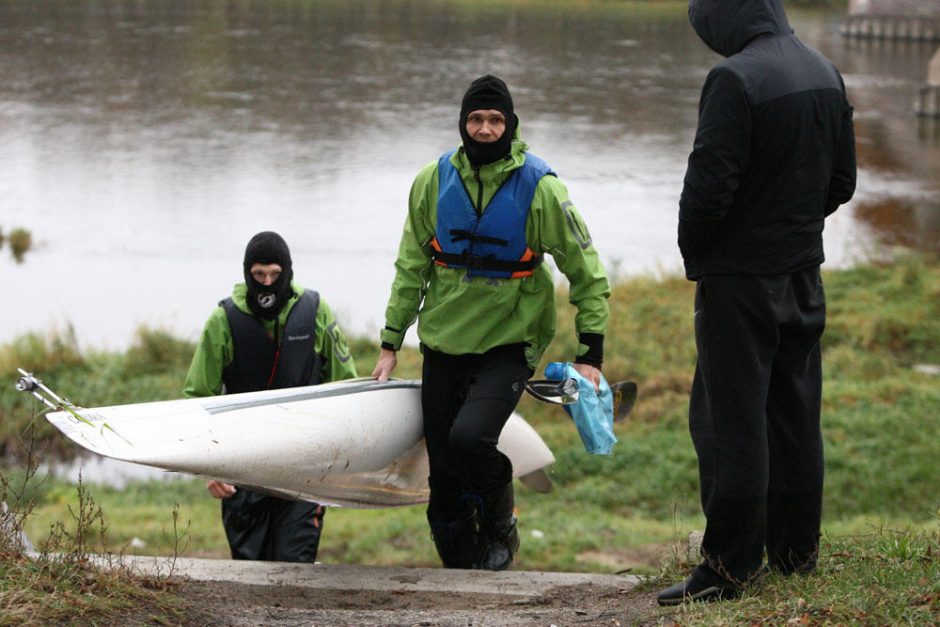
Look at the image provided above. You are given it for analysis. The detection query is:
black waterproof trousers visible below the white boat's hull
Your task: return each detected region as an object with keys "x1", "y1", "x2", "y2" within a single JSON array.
[{"x1": 222, "y1": 487, "x2": 324, "y2": 562}]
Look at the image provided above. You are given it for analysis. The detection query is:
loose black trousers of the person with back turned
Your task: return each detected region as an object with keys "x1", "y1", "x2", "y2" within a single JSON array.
[{"x1": 689, "y1": 267, "x2": 826, "y2": 582}]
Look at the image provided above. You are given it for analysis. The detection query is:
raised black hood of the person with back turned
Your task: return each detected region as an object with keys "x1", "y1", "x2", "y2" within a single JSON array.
[{"x1": 689, "y1": 0, "x2": 793, "y2": 57}]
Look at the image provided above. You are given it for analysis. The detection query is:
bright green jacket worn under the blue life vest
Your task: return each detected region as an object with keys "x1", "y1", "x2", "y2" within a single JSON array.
[{"x1": 381, "y1": 134, "x2": 610, "y2": 370}]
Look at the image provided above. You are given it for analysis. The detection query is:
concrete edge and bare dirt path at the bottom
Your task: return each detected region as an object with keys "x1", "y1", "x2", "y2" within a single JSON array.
[{"x1": 122, "y1": 556, "x2": 671, "y2": 627}]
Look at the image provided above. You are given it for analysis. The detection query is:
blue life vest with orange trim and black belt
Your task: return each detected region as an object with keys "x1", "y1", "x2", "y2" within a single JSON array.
[{"x1": 431, "y1": 150, "x2": 555, "y2": 279}]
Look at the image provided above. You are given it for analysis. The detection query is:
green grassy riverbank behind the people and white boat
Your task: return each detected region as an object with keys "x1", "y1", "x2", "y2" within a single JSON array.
[{"x1": 0, "y1": 257, "x2": 940, "y2": 624}]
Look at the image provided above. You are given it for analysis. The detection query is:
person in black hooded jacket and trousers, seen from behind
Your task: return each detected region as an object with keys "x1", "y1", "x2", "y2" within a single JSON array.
[{"x1": 658, "y1": 0, "x2": 855, "y2": 605}]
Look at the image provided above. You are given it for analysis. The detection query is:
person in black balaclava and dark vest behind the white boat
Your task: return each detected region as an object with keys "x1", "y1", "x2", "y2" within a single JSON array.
[{"x1": 183, "y1": 231, "x2": 356, "y2": 562}]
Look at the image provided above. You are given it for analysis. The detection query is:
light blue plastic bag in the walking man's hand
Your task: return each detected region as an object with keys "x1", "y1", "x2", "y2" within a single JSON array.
[{"x1": 545, "y1": 361, "x2": 617, "y2": 455}]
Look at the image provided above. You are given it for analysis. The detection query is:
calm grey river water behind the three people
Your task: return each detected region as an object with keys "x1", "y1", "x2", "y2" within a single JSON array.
[{"x1": 0, "y1": 0, "x2": 940, "y2": 354}]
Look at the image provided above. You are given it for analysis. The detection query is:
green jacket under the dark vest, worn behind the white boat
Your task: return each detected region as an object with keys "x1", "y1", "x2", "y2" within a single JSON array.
[{"x1": 183, "y1": 283, "x2": 357, "y2": 398}]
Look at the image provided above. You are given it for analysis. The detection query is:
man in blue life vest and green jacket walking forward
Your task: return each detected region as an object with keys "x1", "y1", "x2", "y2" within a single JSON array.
[{"x1": 372, "y1": 75, "x2": 610, "y2": 570}]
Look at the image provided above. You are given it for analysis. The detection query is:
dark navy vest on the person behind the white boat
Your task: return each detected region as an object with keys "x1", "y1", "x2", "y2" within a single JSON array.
[{"x1": 219, "y1": 289, "x2": 320, "y2": 394}]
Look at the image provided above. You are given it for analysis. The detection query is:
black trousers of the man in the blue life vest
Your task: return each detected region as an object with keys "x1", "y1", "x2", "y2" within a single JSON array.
[{"x1": 421, "y1": 344, "x2": 532, "y2": 522}]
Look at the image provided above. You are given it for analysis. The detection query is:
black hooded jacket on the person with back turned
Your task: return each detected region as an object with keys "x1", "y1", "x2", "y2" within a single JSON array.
[{"x1": 679, "y1": 0, "x2": 855, "y2": 280}]
